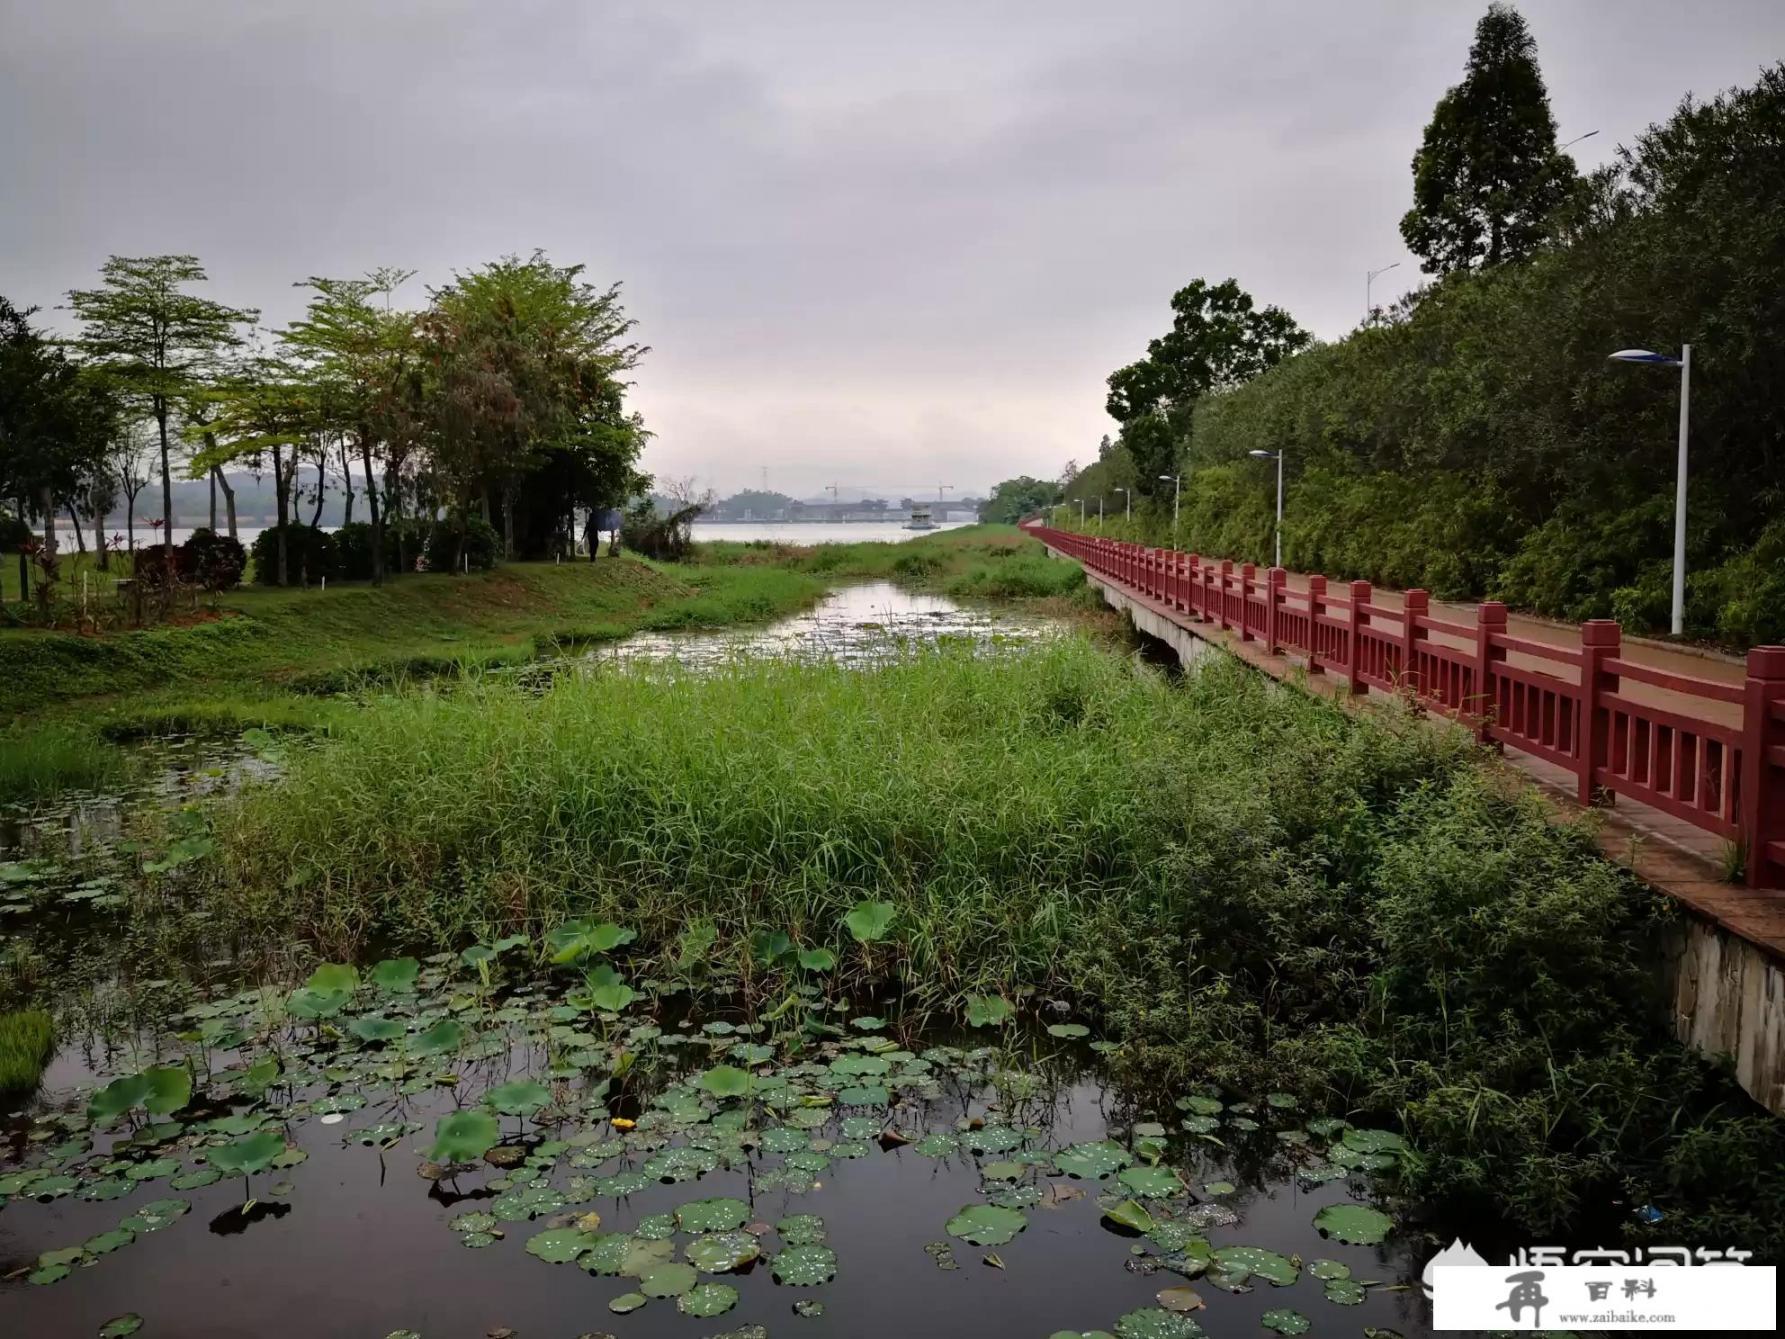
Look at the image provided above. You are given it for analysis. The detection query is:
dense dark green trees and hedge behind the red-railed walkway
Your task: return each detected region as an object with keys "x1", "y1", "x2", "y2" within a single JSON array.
[{"x1": 1062, "y1": 5, "x2": 1785, "y2": 645}]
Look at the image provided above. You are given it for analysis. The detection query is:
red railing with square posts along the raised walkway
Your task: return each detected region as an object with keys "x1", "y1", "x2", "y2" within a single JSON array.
[{"x1": 1025, "y1": 523, "x2": 1785, "y2": 887}]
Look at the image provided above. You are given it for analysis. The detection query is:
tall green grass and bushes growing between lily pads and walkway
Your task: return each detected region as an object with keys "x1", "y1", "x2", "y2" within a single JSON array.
[{"x1": 211, "y1": 641, "x2": 1785, "y2": 1250}]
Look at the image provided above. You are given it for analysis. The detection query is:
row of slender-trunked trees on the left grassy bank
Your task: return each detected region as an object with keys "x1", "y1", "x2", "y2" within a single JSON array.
[{"x1": 0, "y1": 252, "x2": 650, "y2": 586}]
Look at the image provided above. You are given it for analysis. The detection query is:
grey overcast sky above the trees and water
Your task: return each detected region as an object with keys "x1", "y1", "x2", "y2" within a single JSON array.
[{"x1": 0, "y1": 0, "x2": 1785, "y2": 495}]
